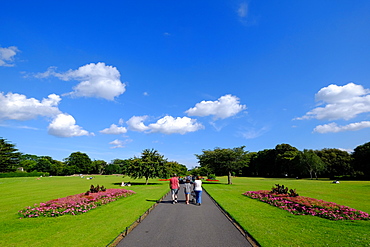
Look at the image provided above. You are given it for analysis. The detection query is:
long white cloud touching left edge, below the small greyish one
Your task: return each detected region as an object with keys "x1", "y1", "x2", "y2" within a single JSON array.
[{"x1": 0, "y1": 93, "x2": 61, "y2": 121}]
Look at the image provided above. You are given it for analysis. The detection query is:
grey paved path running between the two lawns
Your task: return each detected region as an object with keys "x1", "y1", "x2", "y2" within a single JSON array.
[{"x1": 117, "y1": 185, "x2": 252, "y2": 247}]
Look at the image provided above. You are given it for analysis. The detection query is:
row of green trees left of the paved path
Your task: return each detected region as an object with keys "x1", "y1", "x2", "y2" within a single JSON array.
[{"x1": 0, "y1": 138, "x2": 187, "y2": 182}]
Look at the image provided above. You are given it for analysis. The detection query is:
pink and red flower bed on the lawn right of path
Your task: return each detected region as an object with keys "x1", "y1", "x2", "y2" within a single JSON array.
[{"x1": 243, "y1": 190, "x2": 370, "y2": 220}]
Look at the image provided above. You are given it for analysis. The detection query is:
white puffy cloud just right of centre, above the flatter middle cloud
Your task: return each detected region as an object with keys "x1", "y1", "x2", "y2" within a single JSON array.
[{"x1": 185, "y1": 94, "x2": 247, "y2": 120}]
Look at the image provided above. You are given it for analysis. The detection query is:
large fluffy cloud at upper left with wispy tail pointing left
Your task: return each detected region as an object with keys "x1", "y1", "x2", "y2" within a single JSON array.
[{"x1": 35, "y1": 63, "x2": 126, "y2": 100}]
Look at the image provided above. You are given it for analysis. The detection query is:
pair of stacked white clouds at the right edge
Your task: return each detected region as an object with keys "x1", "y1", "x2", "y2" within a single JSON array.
[{"x1": 297, "y1": 83, "x2": 370, "y2": 133}]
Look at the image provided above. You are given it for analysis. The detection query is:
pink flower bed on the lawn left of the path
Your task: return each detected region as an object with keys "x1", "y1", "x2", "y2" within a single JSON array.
[{"x1": 19, "y1": 189, "x2": 135, "y2": 218}]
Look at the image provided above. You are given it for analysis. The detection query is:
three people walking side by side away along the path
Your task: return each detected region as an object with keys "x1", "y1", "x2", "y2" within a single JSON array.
[{"x1": 170, "y1": 174, "x2": 203, "y2": 206}]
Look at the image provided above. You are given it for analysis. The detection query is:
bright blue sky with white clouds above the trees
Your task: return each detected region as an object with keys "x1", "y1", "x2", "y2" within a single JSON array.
[{"x1": 0, "y1": 0, "x2": 370, "y2": 168}]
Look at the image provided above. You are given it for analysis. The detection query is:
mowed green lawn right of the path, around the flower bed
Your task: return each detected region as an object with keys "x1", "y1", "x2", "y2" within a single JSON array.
[{"x1": 203, "y1": 177, "x2": 370, "y2": 247}]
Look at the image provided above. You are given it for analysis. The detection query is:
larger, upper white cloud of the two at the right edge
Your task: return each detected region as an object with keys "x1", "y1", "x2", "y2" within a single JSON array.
[{"x1": 297, "y1": 83, "x2": 370, "y2": 120}]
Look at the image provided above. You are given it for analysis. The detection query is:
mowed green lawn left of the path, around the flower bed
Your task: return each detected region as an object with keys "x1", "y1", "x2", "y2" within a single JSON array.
[{"x1": 0, "y1": 176, "x2": 169, "y2": 246}]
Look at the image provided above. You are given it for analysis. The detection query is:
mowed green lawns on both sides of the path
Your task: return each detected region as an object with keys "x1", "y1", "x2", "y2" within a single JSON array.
[{"x1": 0, "y1": 176, "x2": 370, "y2": 247}]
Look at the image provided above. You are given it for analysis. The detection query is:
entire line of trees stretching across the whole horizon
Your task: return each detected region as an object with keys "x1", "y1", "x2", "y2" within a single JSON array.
[{"x1": 0, "y1": 138, "x2": 370, "y2": 181}]
